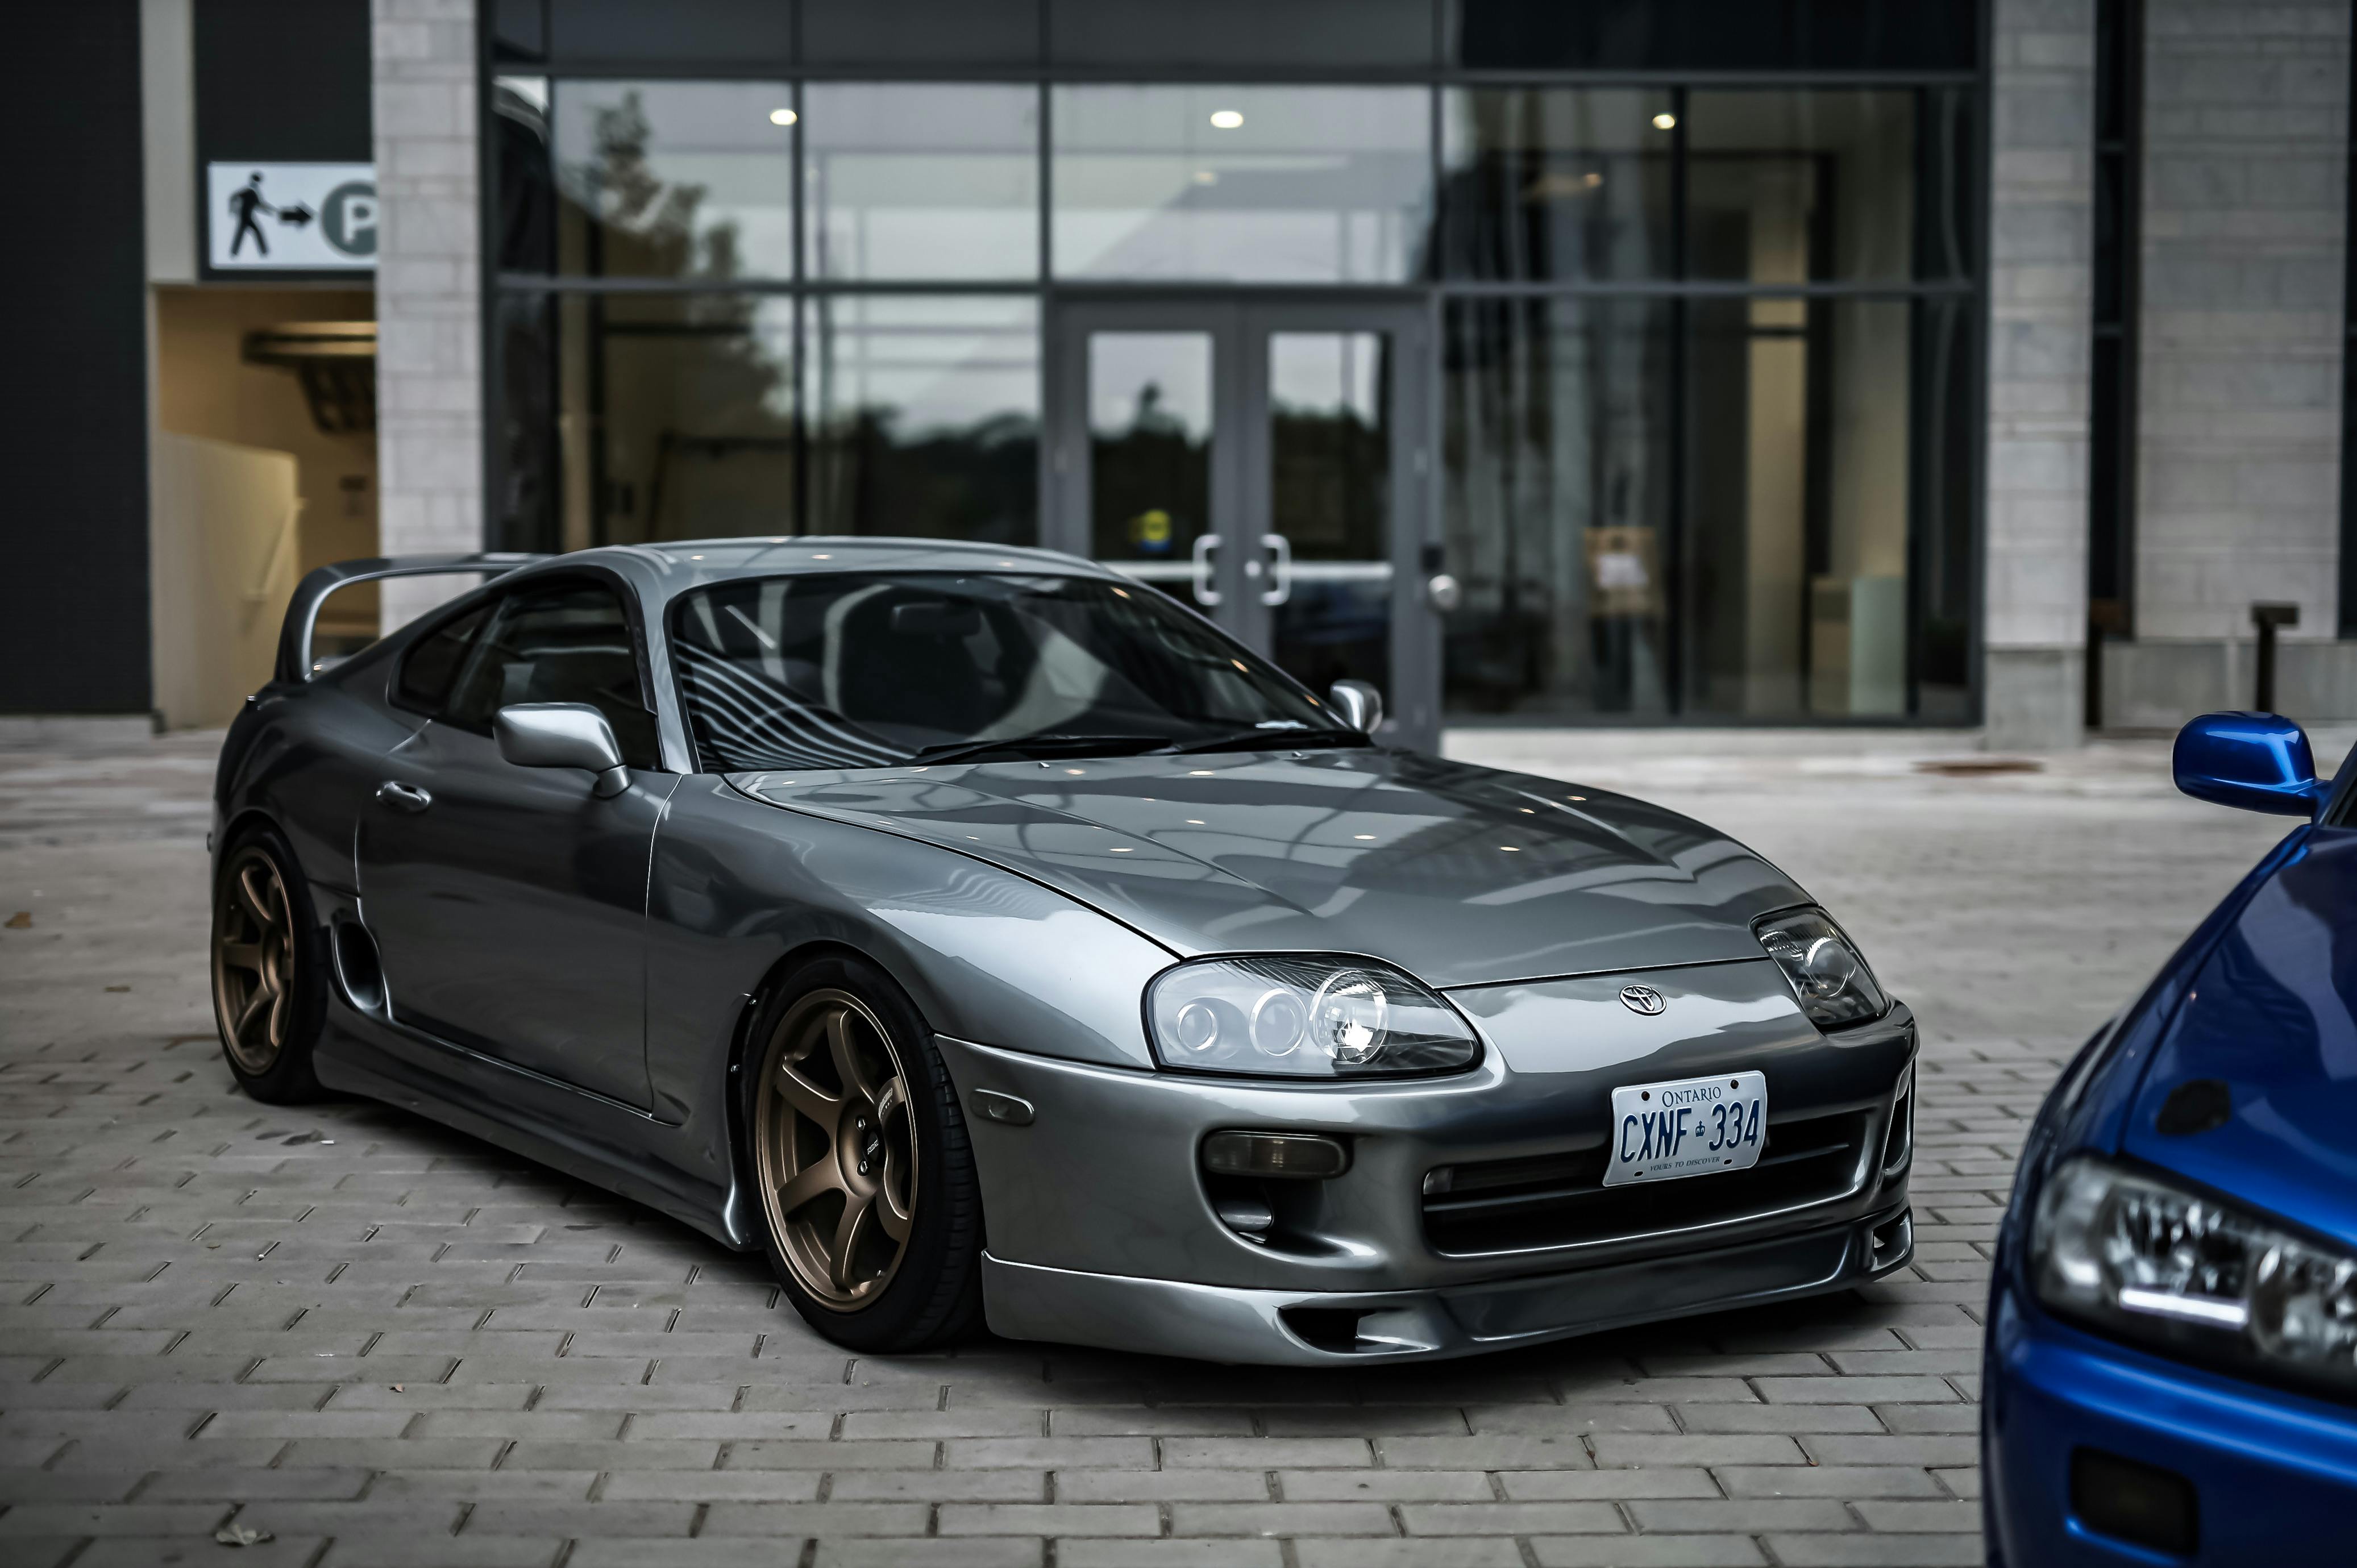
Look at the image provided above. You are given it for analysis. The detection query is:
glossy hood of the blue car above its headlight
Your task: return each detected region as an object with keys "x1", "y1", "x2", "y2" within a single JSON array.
[{"x1": 2123, "y1": 827, "x2": 2357, "y2": 1247}]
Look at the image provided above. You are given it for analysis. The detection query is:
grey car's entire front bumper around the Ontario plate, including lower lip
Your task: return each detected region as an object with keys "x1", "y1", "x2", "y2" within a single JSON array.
[{"x1": 936, "y1": 960, "x2": 1914, "y2": 1363}]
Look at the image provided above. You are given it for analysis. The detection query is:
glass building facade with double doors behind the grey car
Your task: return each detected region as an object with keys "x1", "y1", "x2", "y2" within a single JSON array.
[{"x1": 485, "y1": 0, "x2": 1985, "y2": 724}]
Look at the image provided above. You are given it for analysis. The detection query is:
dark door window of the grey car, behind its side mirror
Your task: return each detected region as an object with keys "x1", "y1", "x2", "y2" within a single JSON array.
[{"x1": 443, "y1": 583, "x2": 662, "y2": 769}]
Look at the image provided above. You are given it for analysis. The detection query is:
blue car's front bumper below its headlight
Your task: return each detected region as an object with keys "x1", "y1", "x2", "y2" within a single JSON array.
[{"x1": 1982, "y1": 1290, "x2": 2357, "y2": 1568}]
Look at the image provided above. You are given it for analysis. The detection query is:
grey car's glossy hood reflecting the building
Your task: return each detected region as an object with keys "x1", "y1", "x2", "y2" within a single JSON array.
[{"x1": 731, "y1": 750, "x2": 1803, "y2": 985}]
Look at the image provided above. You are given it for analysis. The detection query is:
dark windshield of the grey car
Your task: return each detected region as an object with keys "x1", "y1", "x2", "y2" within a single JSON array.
[{"x1": 672, "y1": 573, "x2": 1365, "y2": 773}]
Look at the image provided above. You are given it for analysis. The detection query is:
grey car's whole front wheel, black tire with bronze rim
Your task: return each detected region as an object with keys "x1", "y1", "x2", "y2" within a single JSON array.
[{"x1": 740, "y1": 955, "x2": 983, "y2": 1353}]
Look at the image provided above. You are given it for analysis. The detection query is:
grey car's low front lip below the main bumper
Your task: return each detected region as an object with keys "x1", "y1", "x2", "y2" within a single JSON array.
[{"x1": 983, "y1": 1207, "x2": 1914, "y2": 1365}]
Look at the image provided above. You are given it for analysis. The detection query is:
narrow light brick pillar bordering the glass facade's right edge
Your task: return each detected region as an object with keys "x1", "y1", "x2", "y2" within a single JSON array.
[{"x1": 1982, "y1": 0, "x2": 2096, "y2": 750}]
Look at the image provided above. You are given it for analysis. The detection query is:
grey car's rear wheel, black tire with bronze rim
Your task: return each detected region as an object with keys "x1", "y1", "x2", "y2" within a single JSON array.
[{"x1": 210, "y1": 827, "x2": 327, "y2": 1106}]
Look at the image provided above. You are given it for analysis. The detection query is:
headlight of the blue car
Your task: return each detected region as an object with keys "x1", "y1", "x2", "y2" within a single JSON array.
[{"x1": 2030, "y1": 1158, "x2": 2357, "y2": 1398}]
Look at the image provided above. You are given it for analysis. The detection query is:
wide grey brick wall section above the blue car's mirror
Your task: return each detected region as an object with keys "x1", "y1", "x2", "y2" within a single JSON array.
[{"x1": 2135, "y1": 0, "x2": 2350, "y2": 641}]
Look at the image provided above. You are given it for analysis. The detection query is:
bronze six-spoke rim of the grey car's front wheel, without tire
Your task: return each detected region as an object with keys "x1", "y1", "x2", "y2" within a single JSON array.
[{"x1": 752, "y1": 988, "x2": 919, "y2": 1313}]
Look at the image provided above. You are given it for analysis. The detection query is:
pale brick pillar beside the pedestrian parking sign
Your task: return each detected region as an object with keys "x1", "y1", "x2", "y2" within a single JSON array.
[{"x1": 370, "y1": 0, "x2": 483, "y2": 630}]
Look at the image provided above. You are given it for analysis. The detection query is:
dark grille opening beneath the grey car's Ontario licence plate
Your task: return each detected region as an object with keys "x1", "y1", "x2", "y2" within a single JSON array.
[{"x1": 1424, "y1": 1111, "x2": 1867, "y2": 1252}]
